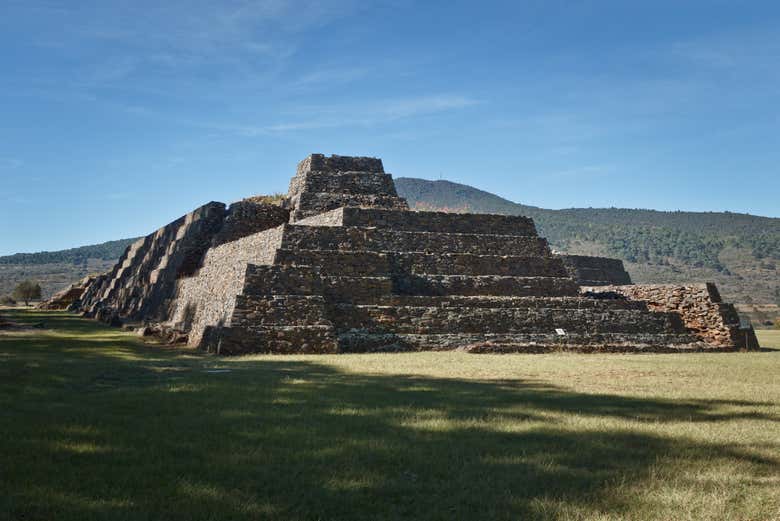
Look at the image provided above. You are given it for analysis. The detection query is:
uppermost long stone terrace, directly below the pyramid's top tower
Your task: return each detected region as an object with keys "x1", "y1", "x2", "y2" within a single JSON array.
[{"x1": 337, "y1": 208, "x2": 537, "y2": 236}]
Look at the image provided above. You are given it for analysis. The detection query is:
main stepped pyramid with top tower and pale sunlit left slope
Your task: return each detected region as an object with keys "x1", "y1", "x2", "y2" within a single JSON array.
[{"x1": 169, "y1": 154, "x2": 708, "y2": 354}]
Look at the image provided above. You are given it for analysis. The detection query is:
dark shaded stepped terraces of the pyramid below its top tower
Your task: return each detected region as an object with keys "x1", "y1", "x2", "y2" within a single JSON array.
[{"x1": 197, "y1": 203, "x2": 704, "y2": 354}]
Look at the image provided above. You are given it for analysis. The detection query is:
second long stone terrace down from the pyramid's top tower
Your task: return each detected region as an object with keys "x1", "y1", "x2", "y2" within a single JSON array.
[{"x1": 280, "y1": 225, "x2": 552, "y2": 257}]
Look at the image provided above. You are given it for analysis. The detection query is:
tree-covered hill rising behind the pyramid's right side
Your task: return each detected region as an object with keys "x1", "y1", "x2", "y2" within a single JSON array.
[{"x1": 395, "y1": 177, "x2": 780, "y2": 303}]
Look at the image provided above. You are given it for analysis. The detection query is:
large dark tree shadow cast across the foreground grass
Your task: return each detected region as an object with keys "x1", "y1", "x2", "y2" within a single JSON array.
[{"x1": 0, "y1": 308, "x2": 777, "y2": 519}]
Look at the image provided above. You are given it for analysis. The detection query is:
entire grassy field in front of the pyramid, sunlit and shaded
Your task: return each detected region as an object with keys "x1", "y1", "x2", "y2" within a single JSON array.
[{"x1": 0, "y1": 310, "x2": 780, "y2": 520}]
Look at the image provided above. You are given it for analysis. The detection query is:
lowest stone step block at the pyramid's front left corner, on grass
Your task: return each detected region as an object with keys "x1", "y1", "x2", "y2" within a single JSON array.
[{"x1": 200, "y1": 325, "x2": 338, "y2": 355}]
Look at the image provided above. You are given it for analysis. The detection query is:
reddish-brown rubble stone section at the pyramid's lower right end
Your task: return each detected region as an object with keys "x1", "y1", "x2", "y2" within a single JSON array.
[{"x1": 583, "y1": 283, "x2": 759, "y2": 349}]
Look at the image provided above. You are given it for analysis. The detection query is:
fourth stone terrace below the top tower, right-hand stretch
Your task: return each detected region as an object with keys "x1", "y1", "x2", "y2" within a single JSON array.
[{"x1": 393, "y1": 275, "x2": 579, "y2": 297}]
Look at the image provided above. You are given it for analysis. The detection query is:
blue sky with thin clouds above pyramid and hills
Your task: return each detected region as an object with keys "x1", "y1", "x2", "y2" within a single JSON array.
[{"x1": 0, "y1": 0, "x2": 780, "y2": 254}]
